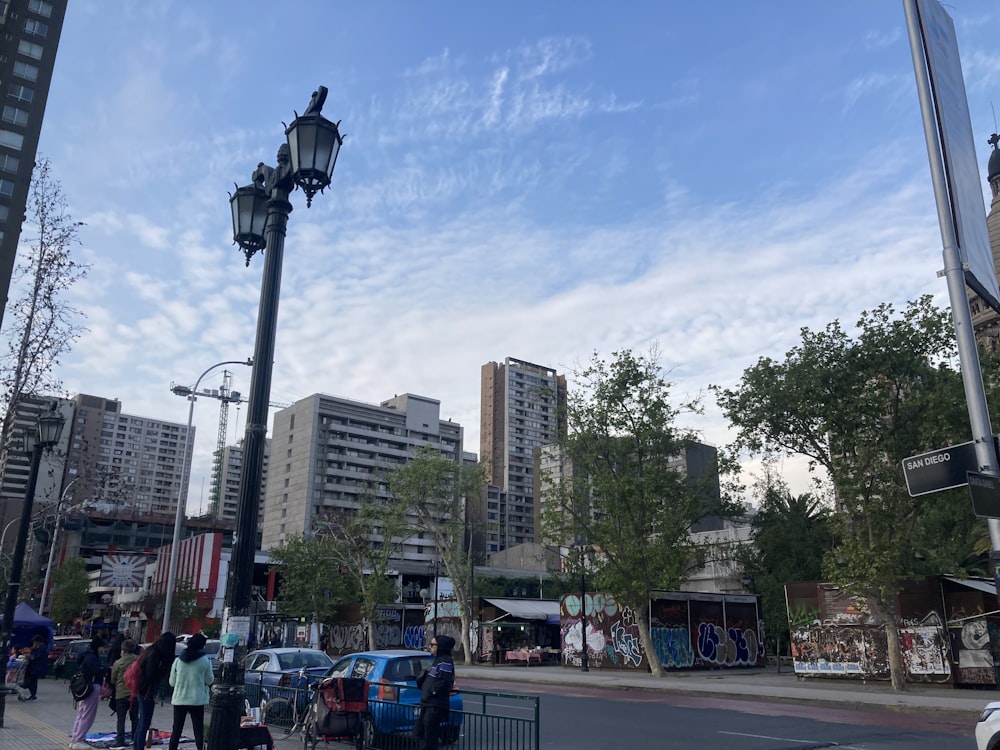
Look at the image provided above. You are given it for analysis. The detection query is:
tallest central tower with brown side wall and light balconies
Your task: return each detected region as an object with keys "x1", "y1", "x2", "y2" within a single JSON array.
[{"x1": 479, "y1": 357, "x2": 566, "y2": 553}]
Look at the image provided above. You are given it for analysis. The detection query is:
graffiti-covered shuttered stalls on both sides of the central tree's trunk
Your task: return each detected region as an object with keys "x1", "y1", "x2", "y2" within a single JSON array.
[{"x1": 559, "y1": 592, "x2": 764, "y2": 671}]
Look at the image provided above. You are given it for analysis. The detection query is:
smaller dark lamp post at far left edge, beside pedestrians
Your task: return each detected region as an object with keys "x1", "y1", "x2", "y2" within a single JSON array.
[{"x1": 0, "y1": 401, "x2": 65, "y2": 727}]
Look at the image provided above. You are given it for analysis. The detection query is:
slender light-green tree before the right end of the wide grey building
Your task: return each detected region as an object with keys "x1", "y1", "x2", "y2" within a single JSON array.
[{"x1": 389, "y1": 446, "x2": 486, "y2": 664}]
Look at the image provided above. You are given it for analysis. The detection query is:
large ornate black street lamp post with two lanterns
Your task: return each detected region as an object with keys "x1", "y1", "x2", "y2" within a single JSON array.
[{"x1": 208, "y1": 86, "x2": 344, "y2": 750}]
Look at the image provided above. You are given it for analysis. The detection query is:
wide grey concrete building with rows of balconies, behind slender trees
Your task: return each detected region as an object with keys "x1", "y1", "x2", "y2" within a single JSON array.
[{"x1": 262, "y1": 393, "x2": 465, "y2": 563}]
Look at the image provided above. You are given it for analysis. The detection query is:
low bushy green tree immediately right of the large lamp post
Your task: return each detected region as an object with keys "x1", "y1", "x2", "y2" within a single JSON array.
[{"x1": 270, "y1": 535, "x2": 356, "y2": 648}]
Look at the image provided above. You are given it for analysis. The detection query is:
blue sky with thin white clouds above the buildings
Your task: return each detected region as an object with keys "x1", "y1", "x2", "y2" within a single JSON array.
[{"x1": 19, "y1": 0, "x2": 1000, "y2": 508}]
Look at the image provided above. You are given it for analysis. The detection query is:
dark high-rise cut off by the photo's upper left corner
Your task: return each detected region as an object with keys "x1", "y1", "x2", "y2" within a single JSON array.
[{"x1": 0, "y1": 0, "x2": 67, "y2": 323}]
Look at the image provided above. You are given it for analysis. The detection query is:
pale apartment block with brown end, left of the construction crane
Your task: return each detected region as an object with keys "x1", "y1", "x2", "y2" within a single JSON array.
[{"x1": 63, "y1": 394, "x2": 195, "y2": 515}]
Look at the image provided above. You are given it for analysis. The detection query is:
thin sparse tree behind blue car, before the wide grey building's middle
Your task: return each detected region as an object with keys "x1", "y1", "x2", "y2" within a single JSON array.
[{"x1": 320, "y1": 489, "x2": 410, "y2": 648}]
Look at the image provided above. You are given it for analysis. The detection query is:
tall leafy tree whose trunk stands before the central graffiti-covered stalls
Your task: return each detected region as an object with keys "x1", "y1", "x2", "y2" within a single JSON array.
[{"x1": 541, "y1": 350, "x2": 733, "y2": 676}]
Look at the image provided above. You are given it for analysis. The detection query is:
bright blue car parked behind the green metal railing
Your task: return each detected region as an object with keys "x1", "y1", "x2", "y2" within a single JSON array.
[{"x1": 326, "y1": 649, "x2": 463, "y2": 747}]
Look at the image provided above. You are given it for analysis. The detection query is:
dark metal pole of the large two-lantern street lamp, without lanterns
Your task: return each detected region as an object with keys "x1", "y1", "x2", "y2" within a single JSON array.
[{"x1": 208, "y1": 159, "x2": 295, "y2": 750}]
